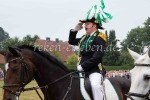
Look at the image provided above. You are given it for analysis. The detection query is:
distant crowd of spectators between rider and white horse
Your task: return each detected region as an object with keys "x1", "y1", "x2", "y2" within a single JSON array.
[{"x1": 106, "y1": 70, "x2": 130, "y2": 79}]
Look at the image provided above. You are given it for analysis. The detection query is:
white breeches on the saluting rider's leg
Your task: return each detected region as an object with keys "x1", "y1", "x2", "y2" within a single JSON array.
[{"x1": 89, "y1": 72, "x2": 103, "y2": 100}]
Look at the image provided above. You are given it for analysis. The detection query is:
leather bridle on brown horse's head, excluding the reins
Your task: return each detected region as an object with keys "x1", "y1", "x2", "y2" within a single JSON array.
[{"x1": 3, "y1": 57, "x2": 30, "y2": 96}]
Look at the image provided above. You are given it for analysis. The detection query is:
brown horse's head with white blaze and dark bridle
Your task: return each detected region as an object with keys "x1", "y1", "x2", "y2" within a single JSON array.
[{"x1": 1, "y1": 47, "x2": 34, "y2": 100}]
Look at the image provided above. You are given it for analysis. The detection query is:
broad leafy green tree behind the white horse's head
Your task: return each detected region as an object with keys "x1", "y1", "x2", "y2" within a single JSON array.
[{"x1": 120, "y1": 17, "x2": 150, "y2": 66}]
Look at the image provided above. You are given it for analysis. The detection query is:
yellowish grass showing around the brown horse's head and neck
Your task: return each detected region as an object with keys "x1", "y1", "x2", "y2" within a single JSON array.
[{"x1": 0, "y1": 81, "x2": 43, "y2": 100}]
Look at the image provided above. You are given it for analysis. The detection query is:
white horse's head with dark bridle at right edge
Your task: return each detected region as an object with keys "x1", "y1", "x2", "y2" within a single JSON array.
[{"x1": 128, "y1": 48, "x2": 150, "y2": 100}]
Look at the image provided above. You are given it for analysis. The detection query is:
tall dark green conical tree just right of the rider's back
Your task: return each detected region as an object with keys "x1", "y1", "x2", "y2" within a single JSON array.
[{"x1": 103, "y1": 30, "x2": 120, "y2": 66}]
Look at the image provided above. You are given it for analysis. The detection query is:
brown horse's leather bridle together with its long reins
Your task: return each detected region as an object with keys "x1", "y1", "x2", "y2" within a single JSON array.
[{"x1": 3, "y1": 57, "x2": 78, "y2": 100}]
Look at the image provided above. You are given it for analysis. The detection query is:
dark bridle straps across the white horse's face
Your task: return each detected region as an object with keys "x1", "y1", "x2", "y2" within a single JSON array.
[{"x1": 126, "y1": 63, "x2": 150, "y2": 100}]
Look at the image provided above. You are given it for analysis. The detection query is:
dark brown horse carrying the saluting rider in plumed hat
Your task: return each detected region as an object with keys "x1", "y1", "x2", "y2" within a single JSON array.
[{"x1": 1, "y1": 45, "x2": 130, "y2": 100}]
